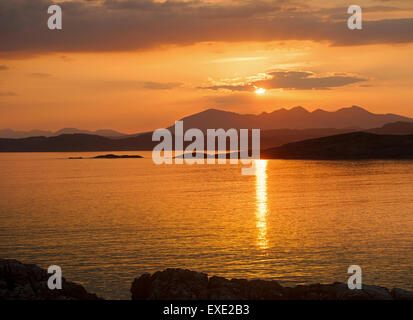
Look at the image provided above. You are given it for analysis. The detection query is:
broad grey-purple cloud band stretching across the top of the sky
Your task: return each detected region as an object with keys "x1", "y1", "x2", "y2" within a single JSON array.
[{"x1": 0, "y1": 0, "x2": 413, "y2": 55}]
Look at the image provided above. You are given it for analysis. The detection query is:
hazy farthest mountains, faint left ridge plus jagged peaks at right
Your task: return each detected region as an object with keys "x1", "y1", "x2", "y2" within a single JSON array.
[{"x1": 0, "y1": 106, "x2": 413, "y2": 139}]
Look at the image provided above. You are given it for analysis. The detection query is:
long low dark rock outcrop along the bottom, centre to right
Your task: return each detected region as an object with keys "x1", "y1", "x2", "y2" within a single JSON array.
[{"x1": 131, "y1": 269, "x2": 413, "y2": 300}]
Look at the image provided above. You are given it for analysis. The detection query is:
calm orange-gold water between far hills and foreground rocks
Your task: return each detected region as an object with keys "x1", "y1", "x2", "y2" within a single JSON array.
[{"x1": 0, "y1": 152, "x2": 413, "y2": 299}]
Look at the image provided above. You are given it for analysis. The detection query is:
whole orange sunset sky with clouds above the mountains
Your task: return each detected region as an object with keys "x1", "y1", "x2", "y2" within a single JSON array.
[{"x1": 0, "y1": 0, "x2": 413, "y2": 133}]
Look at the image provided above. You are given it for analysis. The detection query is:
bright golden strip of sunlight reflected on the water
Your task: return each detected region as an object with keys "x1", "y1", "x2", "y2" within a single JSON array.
[{"x1": 255, "y1": 160, "x2": 268, "y2": 249}]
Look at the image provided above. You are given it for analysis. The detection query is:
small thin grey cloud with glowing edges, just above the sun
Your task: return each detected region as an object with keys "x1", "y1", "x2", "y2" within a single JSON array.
[{"x1": 200, "y1": 71, "x2": 367, "y2": 91}]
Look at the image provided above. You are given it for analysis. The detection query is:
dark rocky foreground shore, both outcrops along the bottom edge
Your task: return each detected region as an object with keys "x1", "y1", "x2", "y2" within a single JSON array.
[{"x1": 0, "y1": 259, "x2": 413, "y2": 300}]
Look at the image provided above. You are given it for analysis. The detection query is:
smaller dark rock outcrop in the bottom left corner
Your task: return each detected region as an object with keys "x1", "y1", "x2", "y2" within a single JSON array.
[{"x1": 0, "y1": 259, "x2": 100, "y2": 300}]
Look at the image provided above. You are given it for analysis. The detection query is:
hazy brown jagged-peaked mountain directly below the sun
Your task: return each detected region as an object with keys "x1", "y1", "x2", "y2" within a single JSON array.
[{"x1": 176, "y1": 106, "x2": 413, "y2": 130}]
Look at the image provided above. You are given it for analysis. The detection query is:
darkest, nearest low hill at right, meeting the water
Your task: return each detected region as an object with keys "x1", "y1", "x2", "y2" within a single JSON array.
[{"x1": 261, "y1": 132, "x2": 413, "y2": 160}]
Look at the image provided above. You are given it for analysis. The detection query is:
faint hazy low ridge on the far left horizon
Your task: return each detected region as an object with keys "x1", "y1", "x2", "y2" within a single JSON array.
[{"x1": 0, "y1": 128, "x2": 126, "y2": 139}]
